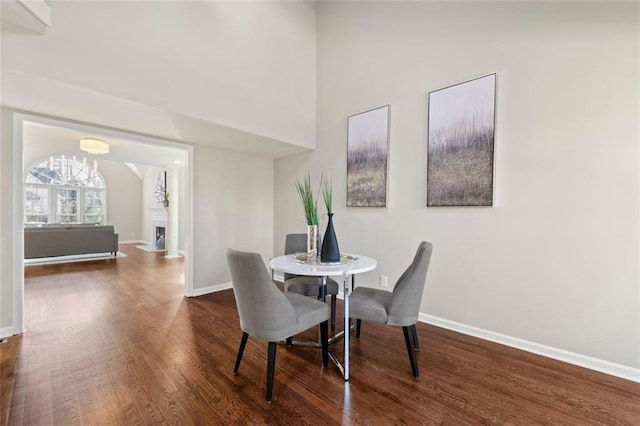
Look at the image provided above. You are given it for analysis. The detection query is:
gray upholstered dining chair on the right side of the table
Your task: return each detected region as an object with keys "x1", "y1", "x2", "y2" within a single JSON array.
[{"x1": 349, "y1": 241, "x2": 433, "y2": 377}]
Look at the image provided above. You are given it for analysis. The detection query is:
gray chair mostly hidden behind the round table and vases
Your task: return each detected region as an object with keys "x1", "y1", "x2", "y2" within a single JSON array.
[{"x1": 284, "y1": 234, "x2": 339, "y2": 330}]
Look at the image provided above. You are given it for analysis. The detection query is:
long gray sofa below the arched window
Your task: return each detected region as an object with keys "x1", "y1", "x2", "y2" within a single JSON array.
[{"x1": 24, "y1": 224, "x2": 118, "y2": 259}]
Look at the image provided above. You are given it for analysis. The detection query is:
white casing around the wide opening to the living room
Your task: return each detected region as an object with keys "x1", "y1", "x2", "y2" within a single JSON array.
[{"x1": 12, "y1": 113, "x2": 194, "y2": 334}]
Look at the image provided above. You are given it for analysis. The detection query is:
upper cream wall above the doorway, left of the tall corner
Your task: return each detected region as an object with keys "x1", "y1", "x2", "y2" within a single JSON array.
[{"x1": 2, "y1": 1, "x2": 316, "y2": 147}]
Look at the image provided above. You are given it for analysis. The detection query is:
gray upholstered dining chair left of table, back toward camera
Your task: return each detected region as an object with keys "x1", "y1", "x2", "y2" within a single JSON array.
[{"x1": 227, "y1": 249, "x2": 329, "y2": 402}]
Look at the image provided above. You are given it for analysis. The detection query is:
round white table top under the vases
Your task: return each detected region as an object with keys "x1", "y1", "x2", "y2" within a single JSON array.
[{"x1": 269, "y1": 254, "x2": 378, "y2": 277}]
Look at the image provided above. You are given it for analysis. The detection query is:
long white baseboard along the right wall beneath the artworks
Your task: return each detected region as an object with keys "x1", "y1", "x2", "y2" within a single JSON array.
[{"x1": 419, "y1": 314, "x2": 640, "y2": 383}]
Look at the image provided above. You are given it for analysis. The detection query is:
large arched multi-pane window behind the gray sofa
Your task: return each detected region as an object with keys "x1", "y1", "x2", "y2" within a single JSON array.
[{"x1": 24, "y1": 155, "x2": 107, "y2": 226}]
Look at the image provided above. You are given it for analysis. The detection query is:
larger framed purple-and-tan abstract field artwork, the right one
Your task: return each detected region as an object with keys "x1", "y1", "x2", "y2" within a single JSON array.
[{"x1": 427, "y1": 74, "x2": 496, "y2": 207}]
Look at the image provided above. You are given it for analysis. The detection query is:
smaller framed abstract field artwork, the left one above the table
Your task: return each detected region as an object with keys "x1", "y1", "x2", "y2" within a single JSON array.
[{"x1": 347, "y1": 105, "x2": 389, "y2": 207}]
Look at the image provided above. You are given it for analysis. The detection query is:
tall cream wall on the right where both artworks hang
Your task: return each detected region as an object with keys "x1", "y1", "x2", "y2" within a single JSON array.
[{"x1": 274, "y1": 2, "x2": 640, "y2": 368}]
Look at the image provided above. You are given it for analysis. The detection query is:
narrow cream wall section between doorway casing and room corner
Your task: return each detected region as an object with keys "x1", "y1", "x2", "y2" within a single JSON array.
[{"x1": 193, "y1": 146, "x2": 273, "y2": 289}]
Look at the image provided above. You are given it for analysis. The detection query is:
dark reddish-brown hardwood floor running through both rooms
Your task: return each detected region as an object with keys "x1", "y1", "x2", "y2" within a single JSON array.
[{"x1": 0, "y1": 245, "x2": 640, "y2": 425}]
